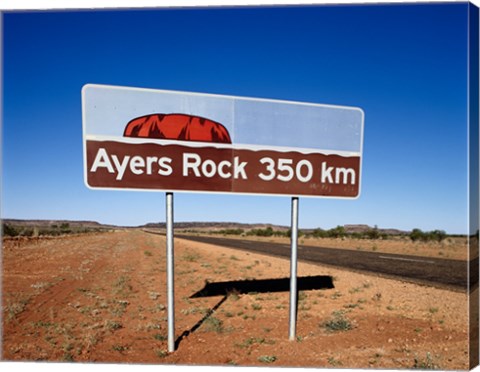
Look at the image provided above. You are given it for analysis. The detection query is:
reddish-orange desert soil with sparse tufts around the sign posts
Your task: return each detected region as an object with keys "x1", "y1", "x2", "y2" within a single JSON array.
[{"x1": 2, "y1": 230, "x2": 468, "y2": 370}]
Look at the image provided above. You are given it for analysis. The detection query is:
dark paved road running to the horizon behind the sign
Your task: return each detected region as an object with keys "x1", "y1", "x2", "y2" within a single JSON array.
[{"x1": 175, "y1": 235, "x2": 478, "y2": 291}]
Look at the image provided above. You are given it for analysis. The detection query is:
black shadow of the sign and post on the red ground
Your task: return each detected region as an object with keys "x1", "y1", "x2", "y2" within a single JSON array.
[{"x1": 175, "y1": 275, "x2": 335, "y2": 348}]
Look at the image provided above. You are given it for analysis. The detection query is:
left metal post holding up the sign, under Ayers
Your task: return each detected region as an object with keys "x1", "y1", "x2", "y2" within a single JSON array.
[{"x1": 166, "y1": 192, "x2": 175, "y2": 353}]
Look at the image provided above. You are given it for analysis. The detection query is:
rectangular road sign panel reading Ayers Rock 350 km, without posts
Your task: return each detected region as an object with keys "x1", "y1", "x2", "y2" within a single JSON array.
[{"x1": 82, "y1": 84, "x2": 364, "y2": 198}]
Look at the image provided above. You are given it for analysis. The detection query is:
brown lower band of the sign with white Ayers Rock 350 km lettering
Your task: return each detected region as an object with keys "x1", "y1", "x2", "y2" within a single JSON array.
[{"x1": 86, "y1": 140, "x2": 360, "y2": 197}]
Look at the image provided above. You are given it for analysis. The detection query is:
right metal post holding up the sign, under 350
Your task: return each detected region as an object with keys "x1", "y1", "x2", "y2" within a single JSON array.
[{"x1": 288, "y1": 197, "x2": 298, "y2": 341}]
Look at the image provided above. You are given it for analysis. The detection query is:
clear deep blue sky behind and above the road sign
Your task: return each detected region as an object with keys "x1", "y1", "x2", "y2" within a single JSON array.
[{"x1": 1, "y1": 3, "x2": 476, "y2": 233}]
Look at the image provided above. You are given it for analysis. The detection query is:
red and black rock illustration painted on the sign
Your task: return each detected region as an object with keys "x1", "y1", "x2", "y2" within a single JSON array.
[{"x1": 123, "y1": 114, "x2": 232, "y2": 143}]
